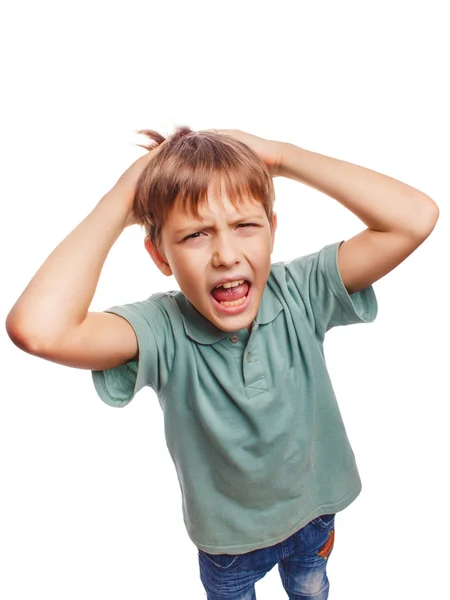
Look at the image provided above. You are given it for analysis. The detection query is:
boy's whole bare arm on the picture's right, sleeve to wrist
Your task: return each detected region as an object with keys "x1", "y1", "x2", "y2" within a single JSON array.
[{"x1": 278, "y1": 143, "x2": 439, "y2": 293}]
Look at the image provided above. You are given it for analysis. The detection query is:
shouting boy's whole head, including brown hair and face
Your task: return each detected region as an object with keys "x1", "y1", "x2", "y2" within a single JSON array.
[{"x1": 134, "y1": 127, "x2": 277, "y2": 331}]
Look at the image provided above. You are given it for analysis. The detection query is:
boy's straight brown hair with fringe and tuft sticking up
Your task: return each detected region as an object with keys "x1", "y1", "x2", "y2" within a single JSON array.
[{"x1": 133, "y1": 126, "x2": 275, "y2": 249}]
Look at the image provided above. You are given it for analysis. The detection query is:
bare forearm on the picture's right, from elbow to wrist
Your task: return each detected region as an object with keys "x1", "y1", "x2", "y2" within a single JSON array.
[{"x1": 279, "y1": 143, "x2": 438, "y2": 235}]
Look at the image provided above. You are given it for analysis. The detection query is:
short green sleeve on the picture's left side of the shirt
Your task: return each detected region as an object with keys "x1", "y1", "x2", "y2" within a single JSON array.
[{"x1": 92, "y1": 296, "x2": 175, "y2": 407}]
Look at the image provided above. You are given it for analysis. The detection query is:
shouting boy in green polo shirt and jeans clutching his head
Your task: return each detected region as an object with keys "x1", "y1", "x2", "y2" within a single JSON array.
[{"x1": 6, "y1": 127, "x2": 439, "y2": 600}]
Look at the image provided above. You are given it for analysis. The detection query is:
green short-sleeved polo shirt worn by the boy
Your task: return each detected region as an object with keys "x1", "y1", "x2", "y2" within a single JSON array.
[{"x1": 92, "y1": 242, "x2": 377, "y2": 554}]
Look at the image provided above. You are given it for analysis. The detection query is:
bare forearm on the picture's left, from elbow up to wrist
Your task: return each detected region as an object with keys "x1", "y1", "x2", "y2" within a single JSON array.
[{"x1": 6, "y1": 191, "x2": 128, "y2": 345}]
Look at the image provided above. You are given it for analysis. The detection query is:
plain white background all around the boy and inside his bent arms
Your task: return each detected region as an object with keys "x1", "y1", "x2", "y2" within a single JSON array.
[{"x1": 0, "y1": 0, "x2": 450, "y2": 600}]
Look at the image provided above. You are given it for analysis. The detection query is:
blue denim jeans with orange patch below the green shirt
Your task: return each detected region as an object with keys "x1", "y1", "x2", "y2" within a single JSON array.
[{"x1": 198, "y1": 514, "x2": 335, "y2": 600}]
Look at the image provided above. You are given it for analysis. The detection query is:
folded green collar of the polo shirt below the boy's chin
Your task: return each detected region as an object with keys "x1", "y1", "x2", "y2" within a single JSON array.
[{"x1": 172, "y1": 275, "x2": 283, "y2": 344}]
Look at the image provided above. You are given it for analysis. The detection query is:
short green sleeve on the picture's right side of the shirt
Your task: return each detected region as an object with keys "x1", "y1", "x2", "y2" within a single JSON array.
[{"x1": 285, "y1": 240, "x2": 378, "y2": 340}]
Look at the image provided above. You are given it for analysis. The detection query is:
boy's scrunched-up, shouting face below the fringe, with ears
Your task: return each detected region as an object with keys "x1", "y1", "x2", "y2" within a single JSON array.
[{"x1": 145, "y1": 184, "x2": 277, "y2": 331}]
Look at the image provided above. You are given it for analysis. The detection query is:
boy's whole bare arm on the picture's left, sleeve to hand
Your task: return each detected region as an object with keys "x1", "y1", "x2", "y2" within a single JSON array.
[{"x1": 6, "y1": 153, "x2": 156, "y2": 369}]
